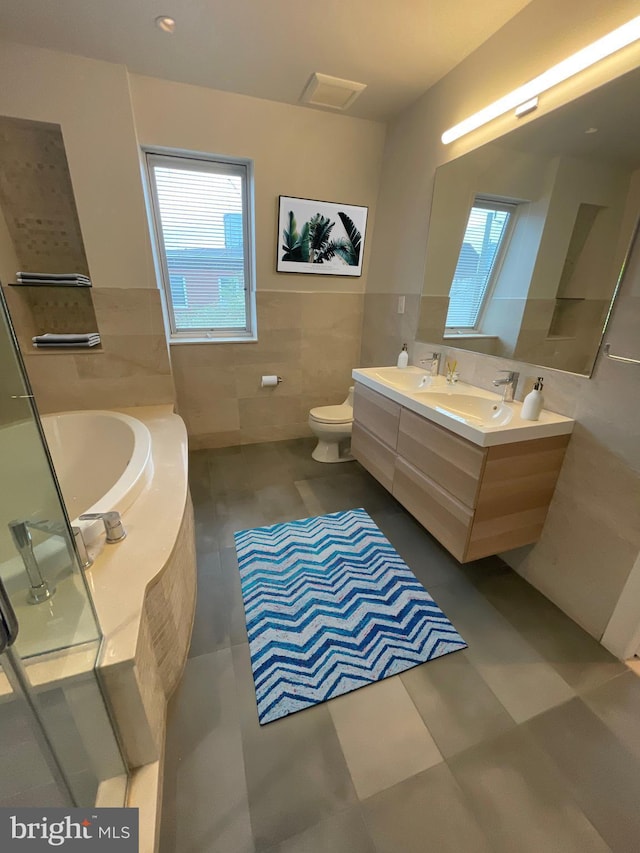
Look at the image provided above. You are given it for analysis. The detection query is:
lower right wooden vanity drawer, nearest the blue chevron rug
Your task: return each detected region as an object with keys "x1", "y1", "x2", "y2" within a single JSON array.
[{"x1": 393, "y1": 456, "x2": 473, "y2": 561}]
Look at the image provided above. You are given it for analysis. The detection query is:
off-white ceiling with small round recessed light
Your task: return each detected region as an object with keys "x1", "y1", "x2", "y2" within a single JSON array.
[{"x1": 0, "y1": 0, "x2": 529, "y2": 121}]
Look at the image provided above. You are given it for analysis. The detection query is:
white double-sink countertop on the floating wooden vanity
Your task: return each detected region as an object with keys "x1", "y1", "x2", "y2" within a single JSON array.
[{"x1": 351, "y1": 366, "x2": 575, "y2": 447}]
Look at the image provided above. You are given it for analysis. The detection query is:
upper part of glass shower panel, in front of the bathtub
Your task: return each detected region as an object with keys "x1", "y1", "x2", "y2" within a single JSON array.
[{"x1": 0, "y1": 306, "x2": 100, "y2": 658}]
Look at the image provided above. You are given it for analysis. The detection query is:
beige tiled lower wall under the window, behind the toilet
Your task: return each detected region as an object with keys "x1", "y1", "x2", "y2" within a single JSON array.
[{"x1": 171, "y1": 291, "x2": 364, "y2": 449}]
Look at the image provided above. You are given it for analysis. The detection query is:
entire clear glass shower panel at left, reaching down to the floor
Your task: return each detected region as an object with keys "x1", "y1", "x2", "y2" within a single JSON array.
[{"x1": 0, "y1": 290, "x2": 126, "y2": 806}]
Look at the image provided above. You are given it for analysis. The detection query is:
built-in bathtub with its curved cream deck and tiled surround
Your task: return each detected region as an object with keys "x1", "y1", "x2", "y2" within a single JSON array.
[{"x1": 0, "y1": 404, "x2": 196, "y2": 850}]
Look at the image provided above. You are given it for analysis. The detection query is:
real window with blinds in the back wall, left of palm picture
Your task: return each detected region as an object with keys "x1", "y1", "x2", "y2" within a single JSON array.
[{"x1": 147, "y1": 152, "x2": 254, "y2": 342}]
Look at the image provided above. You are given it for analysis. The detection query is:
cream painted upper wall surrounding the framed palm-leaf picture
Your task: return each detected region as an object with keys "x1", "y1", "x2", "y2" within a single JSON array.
[{"x1": 130, "y1": 74, "x2": 386, "y2": 292}]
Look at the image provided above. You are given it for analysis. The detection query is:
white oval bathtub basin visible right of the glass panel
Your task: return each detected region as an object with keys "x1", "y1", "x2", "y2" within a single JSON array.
[{"x1": 42, "y1": 411, "x2": 153, "y2": 545}]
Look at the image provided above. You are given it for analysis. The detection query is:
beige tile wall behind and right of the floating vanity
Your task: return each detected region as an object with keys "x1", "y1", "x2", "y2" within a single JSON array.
[{"x1": 361, "y1": 243, "x2": 640, "y2": 638}]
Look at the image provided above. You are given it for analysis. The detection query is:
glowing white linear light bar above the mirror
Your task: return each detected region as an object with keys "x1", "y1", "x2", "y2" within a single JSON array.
[{"x1": 442, "y1": 15, "x2": 640, "y2": 145}]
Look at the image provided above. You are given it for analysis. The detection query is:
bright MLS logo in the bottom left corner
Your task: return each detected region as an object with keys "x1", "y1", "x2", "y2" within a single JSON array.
[{"x1": 0, "y1": 808, "x2": 138, "y2": 853}]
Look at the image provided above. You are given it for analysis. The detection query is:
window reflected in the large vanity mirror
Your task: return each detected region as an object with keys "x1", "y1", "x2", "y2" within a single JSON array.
[{"x1": 445, "y1": 198, "x2": 516, "y2": 331}]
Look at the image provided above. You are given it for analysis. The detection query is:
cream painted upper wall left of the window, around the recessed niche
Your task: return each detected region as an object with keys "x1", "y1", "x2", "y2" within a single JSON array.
[{"x1": 0, "y1": 42, "x2": 155, "y2": 288}]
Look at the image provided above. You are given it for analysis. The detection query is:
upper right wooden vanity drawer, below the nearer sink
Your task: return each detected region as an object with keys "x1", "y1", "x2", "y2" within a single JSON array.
[{"x1": 398, "y1": 409, "x2": 487, "y2": 507}]
